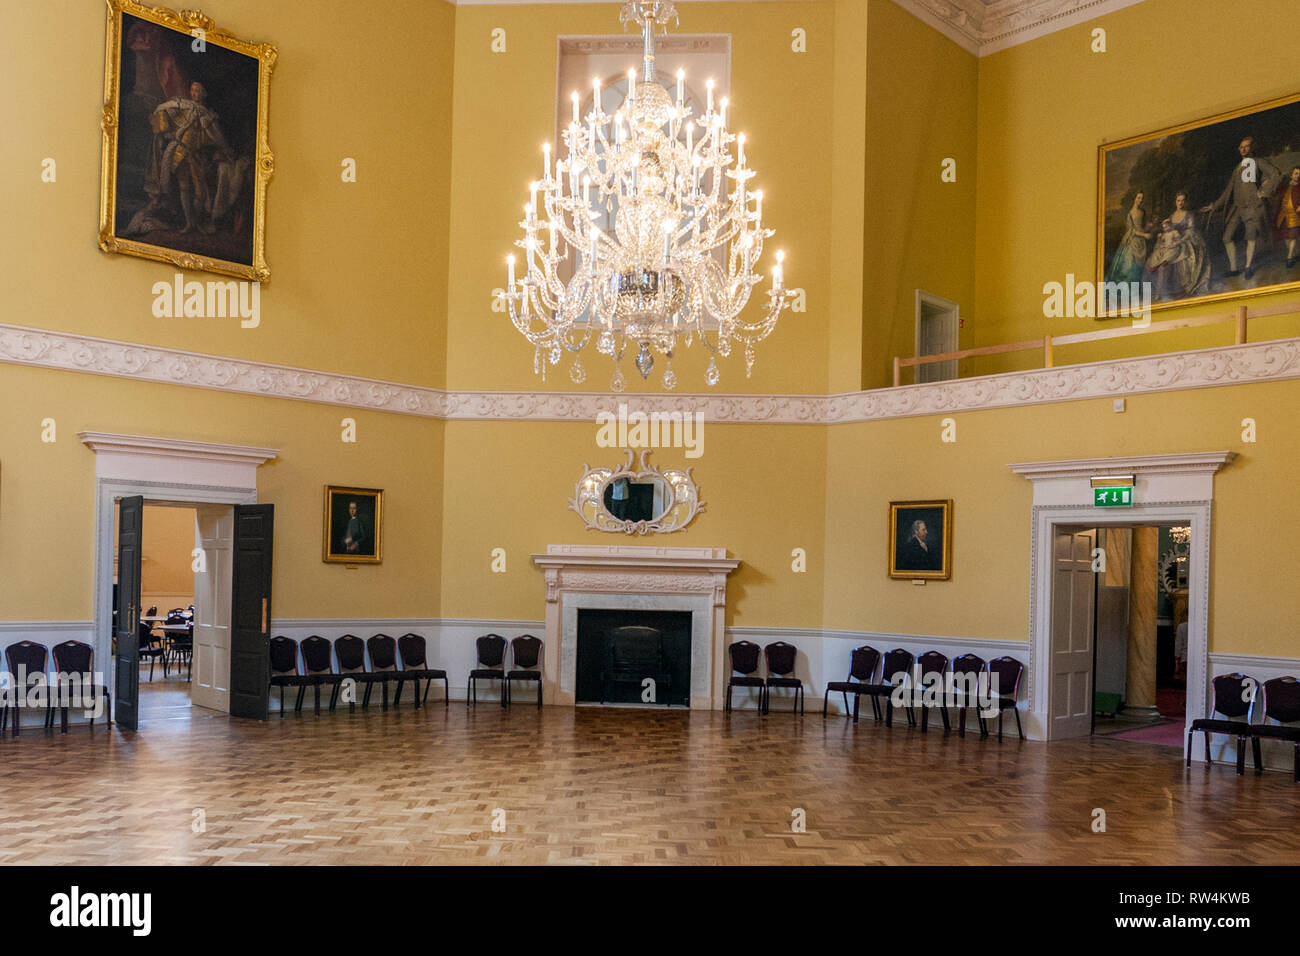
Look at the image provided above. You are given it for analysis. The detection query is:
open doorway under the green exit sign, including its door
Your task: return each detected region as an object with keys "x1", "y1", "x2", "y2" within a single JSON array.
[{"x1": 1052, "y1": 524, "x2": 1191, "y2": 748}]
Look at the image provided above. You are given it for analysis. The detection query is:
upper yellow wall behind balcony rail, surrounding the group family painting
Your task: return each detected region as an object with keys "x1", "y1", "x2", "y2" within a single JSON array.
[{"x1": 977, "y1": 0, "x2": 1300, "y2": 375}]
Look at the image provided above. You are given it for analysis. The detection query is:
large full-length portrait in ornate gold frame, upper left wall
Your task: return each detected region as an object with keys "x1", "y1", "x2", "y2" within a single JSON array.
[{"x1": 99, "y1": 0, "x2": 276, "y2": 282}]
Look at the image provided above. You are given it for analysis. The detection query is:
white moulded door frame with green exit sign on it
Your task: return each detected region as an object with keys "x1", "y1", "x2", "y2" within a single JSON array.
[{"x1": 1010, "y1": 451, "x2": 1235, "y2": 754}]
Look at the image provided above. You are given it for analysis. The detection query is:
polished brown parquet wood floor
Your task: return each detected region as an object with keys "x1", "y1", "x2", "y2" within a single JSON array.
[{"x1": 0, "y1": 702, "x2": 1300, "y2": 864}]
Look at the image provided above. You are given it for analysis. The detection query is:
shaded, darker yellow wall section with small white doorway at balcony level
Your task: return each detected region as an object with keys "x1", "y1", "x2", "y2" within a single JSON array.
[{"x1": 861, "y1": 0, "x2": 978, "y2": 389}]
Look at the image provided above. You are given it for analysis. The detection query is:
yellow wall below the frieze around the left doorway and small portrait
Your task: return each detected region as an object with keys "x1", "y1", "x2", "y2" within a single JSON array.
[{"x1": 0, "y1": 365, "x2": 442, "y2": 620}]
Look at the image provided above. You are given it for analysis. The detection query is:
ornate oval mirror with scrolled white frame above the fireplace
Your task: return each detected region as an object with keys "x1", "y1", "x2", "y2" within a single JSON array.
[{"x1": 569, "y1": 449, "x2": 705, "y2": 535}]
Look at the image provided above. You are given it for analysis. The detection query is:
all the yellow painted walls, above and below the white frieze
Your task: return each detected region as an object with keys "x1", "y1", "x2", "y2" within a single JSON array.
[{"x1": 0, "y1": 0, "x2": 1300, "y2": 671}]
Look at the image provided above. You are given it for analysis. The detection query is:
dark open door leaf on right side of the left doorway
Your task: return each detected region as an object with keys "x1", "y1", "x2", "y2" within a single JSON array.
[{"x1": 230, "y1": 505, "x2": 276, "y2": 721}]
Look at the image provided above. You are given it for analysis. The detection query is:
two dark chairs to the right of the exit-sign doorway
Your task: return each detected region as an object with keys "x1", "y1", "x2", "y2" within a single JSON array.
[{"x1": 1187, "y1": 672, "x2": 1300, "y2": 783}]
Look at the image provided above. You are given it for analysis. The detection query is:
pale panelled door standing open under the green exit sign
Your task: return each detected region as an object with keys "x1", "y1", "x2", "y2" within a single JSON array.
[{"x1": 1048, "y1": 528, "x2": 1097, "y2": 740}]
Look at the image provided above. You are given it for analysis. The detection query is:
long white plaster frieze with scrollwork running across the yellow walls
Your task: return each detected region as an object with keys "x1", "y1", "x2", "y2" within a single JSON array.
[{"x1": 0, "y1": 324, "x2": 1300, "y2": 425}]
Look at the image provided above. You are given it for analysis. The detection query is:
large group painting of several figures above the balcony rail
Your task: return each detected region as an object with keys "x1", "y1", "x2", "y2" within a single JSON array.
[{"x1": 1097, "y1": 94, "x2": 1300, "y2": 308}]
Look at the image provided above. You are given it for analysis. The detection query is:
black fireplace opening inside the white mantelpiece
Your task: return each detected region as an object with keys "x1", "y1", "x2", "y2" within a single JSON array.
[{"x1": 576, "y1": 607, "x2": 690, "y2": 706}]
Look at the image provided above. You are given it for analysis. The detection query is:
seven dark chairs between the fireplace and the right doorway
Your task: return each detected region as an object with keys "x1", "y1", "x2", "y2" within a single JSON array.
[{"x1": 723, "y1": 641, "x2": 1024, "y2": 740}]
